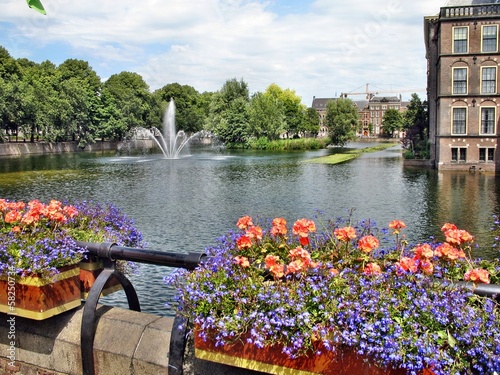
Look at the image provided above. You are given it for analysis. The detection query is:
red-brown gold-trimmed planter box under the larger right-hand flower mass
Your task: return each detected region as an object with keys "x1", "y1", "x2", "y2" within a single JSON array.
[{"x1": 194, "y1": 332, "x2": 433, "y2": 375}]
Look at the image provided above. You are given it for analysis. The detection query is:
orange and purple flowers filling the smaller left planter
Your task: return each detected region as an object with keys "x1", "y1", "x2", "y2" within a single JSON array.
[{"x1": 0, "y1": 199, "x2": 143, "y2": 317}]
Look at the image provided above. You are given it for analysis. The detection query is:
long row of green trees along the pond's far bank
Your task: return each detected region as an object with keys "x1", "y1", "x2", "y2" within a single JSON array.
[{"x1": 0, "y1": 46, "x2": 426, "y2": 151}]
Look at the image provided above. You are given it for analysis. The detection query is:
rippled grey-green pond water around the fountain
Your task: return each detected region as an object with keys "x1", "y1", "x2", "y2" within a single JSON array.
[{"x1": 0, "y1": 143, "x2": 500, "y2": 315}]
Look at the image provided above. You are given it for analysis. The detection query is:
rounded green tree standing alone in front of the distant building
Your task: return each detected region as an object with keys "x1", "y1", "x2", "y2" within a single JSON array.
[{"x1": 325, "y1": 98, "x2": 359, "y2": 147}]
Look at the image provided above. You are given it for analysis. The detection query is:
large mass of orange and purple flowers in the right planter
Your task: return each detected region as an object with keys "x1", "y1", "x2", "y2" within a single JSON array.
[{"x1": 168, "y1": 217, "x2": 500, "y2": 374}]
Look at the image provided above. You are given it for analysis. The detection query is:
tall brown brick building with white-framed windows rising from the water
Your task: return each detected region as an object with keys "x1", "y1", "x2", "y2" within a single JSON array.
[{"x1": 424, "y1": 0, "x2": 500, "y2": 171}]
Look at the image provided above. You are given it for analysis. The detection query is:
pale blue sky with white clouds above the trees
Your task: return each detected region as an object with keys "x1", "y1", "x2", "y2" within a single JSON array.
[{"x1": 0, "y1": 0, "x2": 446, "y2": 106}]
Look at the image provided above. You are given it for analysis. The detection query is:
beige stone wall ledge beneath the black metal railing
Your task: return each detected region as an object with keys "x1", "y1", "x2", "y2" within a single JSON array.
[{"x1": 0, "y1": 305, "x2": 266, "y2": 375}]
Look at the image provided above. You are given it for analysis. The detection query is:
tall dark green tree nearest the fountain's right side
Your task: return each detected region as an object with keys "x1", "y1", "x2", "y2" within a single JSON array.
[{"x1": 207, "y1": 78, "x2": 250, "y2": 145}]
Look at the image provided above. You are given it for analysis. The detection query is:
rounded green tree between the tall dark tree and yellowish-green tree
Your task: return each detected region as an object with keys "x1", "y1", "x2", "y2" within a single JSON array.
[{"x1": 248, "y1": 92, "x2": 285, "y2": 140}]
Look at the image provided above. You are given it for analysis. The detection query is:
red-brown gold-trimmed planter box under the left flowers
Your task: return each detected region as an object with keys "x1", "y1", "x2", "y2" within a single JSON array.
[{"x1": 0, "y1": 264, "x2": 81, "y2": 320}]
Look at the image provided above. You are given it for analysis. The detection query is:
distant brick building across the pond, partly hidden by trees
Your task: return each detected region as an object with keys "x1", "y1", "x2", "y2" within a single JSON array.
[{"x1": 312, "y1": 96, "x2": 408, "y2": 137}]
